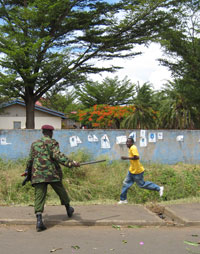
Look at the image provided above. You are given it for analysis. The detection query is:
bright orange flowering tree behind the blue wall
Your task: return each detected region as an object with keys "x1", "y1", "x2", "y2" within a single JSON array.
[{"x1": 78, "y1": 105, "x2": 135, "y2": 129}]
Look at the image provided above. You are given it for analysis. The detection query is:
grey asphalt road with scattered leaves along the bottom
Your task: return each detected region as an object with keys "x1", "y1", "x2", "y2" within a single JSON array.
[{"x1": 0, "y1": 225, "x2": 200, "y2": 254}]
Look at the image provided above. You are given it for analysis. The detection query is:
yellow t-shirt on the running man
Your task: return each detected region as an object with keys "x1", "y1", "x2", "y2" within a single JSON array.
[{"x1": 129, "y1": 145, "x2": 144, "y2": 174}]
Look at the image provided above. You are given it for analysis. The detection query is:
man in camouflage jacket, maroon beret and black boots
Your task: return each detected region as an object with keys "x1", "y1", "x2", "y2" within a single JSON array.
[{"x1": 24, "y1": 125, "x2": 80, "y2": 232}]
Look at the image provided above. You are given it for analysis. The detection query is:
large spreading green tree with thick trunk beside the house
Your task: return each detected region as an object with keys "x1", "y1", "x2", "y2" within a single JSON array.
[{"x1": 0, "y1": 0, "x2": 182, "y2": 128}]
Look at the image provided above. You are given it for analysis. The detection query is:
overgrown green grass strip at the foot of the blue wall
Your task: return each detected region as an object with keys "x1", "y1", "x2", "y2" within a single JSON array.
[{"x1": 0, "y1": 151, "x2": 200, "y2": 205}]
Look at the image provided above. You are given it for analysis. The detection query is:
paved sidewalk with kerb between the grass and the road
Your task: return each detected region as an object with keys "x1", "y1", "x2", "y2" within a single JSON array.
[{"x1": 0, "y1": 203, "x2": 200, "y2": 226}]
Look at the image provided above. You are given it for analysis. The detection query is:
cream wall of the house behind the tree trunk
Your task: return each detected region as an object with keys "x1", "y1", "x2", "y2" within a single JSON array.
[{"x1": 0, "y1": 105, "x2": 62, "y2": 129}]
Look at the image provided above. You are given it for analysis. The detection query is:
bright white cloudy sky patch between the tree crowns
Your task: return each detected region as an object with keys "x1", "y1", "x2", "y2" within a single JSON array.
[{"x1": 90, "y1": 43, "x2": 172, "y2": 90}]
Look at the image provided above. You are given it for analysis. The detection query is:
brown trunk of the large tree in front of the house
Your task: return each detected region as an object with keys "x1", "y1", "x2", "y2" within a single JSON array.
[{"x1": 25, "y1": 97, "x2": 35, "y2": 129}]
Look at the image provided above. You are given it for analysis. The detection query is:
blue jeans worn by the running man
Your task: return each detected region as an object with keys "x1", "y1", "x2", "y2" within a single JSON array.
[{"x1": 120, "y1": 171, "x2": 160, "y2": 200}]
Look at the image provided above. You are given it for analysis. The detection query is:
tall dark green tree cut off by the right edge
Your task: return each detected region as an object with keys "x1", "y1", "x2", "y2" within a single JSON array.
[{"x1": 160, "y1": 1, "x2": 200, "y2": 109}]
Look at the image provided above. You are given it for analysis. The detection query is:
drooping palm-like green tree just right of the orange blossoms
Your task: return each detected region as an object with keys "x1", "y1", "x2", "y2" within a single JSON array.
[{"x1": 121, "y1": 83, "x2": 158, "y2": 129}]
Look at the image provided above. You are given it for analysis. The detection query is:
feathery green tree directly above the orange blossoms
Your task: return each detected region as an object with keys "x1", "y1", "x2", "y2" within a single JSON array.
[{"x1": 76, "y1": 77, "x2": 134, "y2": 108}]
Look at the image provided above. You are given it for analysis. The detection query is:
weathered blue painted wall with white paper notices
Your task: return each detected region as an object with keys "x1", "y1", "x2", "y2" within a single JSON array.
[{"x1": 0, "y1": 129, "x2": 200, "y2": 164}]
